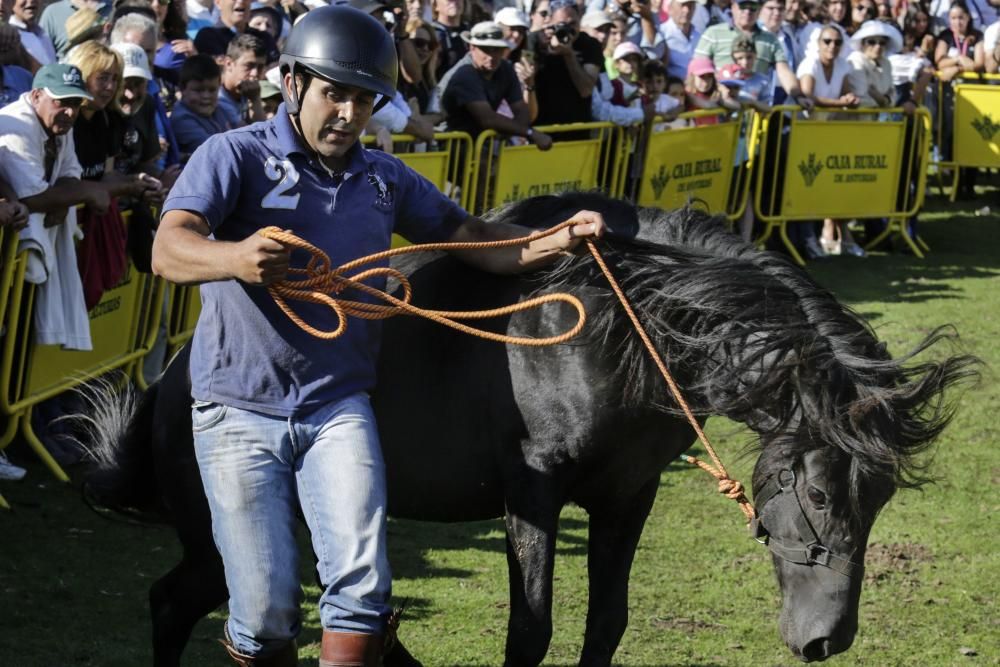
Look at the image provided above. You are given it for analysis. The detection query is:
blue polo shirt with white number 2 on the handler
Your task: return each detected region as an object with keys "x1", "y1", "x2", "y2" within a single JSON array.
[{"x1": 164, "y1": 105, "x2": 468, "y2": 417}]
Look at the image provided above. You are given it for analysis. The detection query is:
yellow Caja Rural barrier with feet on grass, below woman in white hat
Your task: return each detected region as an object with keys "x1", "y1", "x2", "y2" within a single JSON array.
[{"x1": 754, "y1": 107, "x2": 931, "y2": 264}]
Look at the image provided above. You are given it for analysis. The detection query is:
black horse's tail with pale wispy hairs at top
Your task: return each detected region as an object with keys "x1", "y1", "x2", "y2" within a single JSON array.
[{"x1": 75, "y1": 382, "x2": 160, "y2": 518}]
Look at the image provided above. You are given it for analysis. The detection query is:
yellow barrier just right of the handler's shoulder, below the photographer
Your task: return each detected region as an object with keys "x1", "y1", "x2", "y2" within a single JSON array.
[{"x1": 466, "y1": 123, "x2": 626, "y2": 214}]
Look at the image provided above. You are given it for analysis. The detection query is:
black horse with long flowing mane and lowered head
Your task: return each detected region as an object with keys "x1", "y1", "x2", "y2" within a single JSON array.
[{"x1": 89, "y1": 194, "x2": 976, "y2": 667}]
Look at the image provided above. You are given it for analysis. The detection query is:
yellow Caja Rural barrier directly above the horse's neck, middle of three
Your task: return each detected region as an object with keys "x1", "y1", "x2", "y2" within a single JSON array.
[{"x1": 635, "y1": 109, "x2": 759, "y2": 220}]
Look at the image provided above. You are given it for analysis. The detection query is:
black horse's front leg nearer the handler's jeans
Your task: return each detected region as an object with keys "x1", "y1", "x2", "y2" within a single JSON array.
[{"x1": 504, "y1": 454, "x2": 562, "y2": 667}]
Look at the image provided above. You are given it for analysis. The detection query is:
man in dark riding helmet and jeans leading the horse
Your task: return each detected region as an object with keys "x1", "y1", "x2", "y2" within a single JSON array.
[{"x1": 153, "y1": 6, "x2": 604, "y2": 667}]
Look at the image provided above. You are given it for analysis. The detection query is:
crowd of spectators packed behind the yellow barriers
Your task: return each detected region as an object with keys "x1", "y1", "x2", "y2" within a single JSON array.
[{"x1": 0, "y1": 0, "x2": 1000, "y2": 480}]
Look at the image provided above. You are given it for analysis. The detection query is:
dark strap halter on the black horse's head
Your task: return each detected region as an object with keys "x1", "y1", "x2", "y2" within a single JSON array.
[{"x1": 750, "y1": 470, "x2": 865, "y2": 577}]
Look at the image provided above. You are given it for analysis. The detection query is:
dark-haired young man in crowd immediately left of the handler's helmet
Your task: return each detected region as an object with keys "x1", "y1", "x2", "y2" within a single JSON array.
[{"x1": 219, "y1": 35, "x2": 267, "y2": 127}]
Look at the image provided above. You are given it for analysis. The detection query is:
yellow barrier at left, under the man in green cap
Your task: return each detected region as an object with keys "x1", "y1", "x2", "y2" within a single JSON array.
[{"x1": 0, "y1": 213, "x2": 163, "y2": 481}]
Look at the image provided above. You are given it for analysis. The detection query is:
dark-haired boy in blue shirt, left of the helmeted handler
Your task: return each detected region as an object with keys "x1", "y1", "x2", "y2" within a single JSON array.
[{"x1": 170, "y1": 54, "x2": 233, "y2": 156}]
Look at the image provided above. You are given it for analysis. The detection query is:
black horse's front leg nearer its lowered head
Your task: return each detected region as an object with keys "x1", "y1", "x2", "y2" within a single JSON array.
[{"x1": 580, "y1": 476, "x2": 660, "y2": 667}]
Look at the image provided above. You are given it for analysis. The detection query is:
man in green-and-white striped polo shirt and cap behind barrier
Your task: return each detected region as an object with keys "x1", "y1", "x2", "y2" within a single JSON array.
[{"x1": 695, "y1": 0, "x2": 812, "y2": 108}]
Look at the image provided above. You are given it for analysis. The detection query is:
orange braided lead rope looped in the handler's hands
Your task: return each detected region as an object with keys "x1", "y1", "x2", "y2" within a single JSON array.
[{"x1": 258, "y1": 220, "x2": 754, "y2": 521}]
